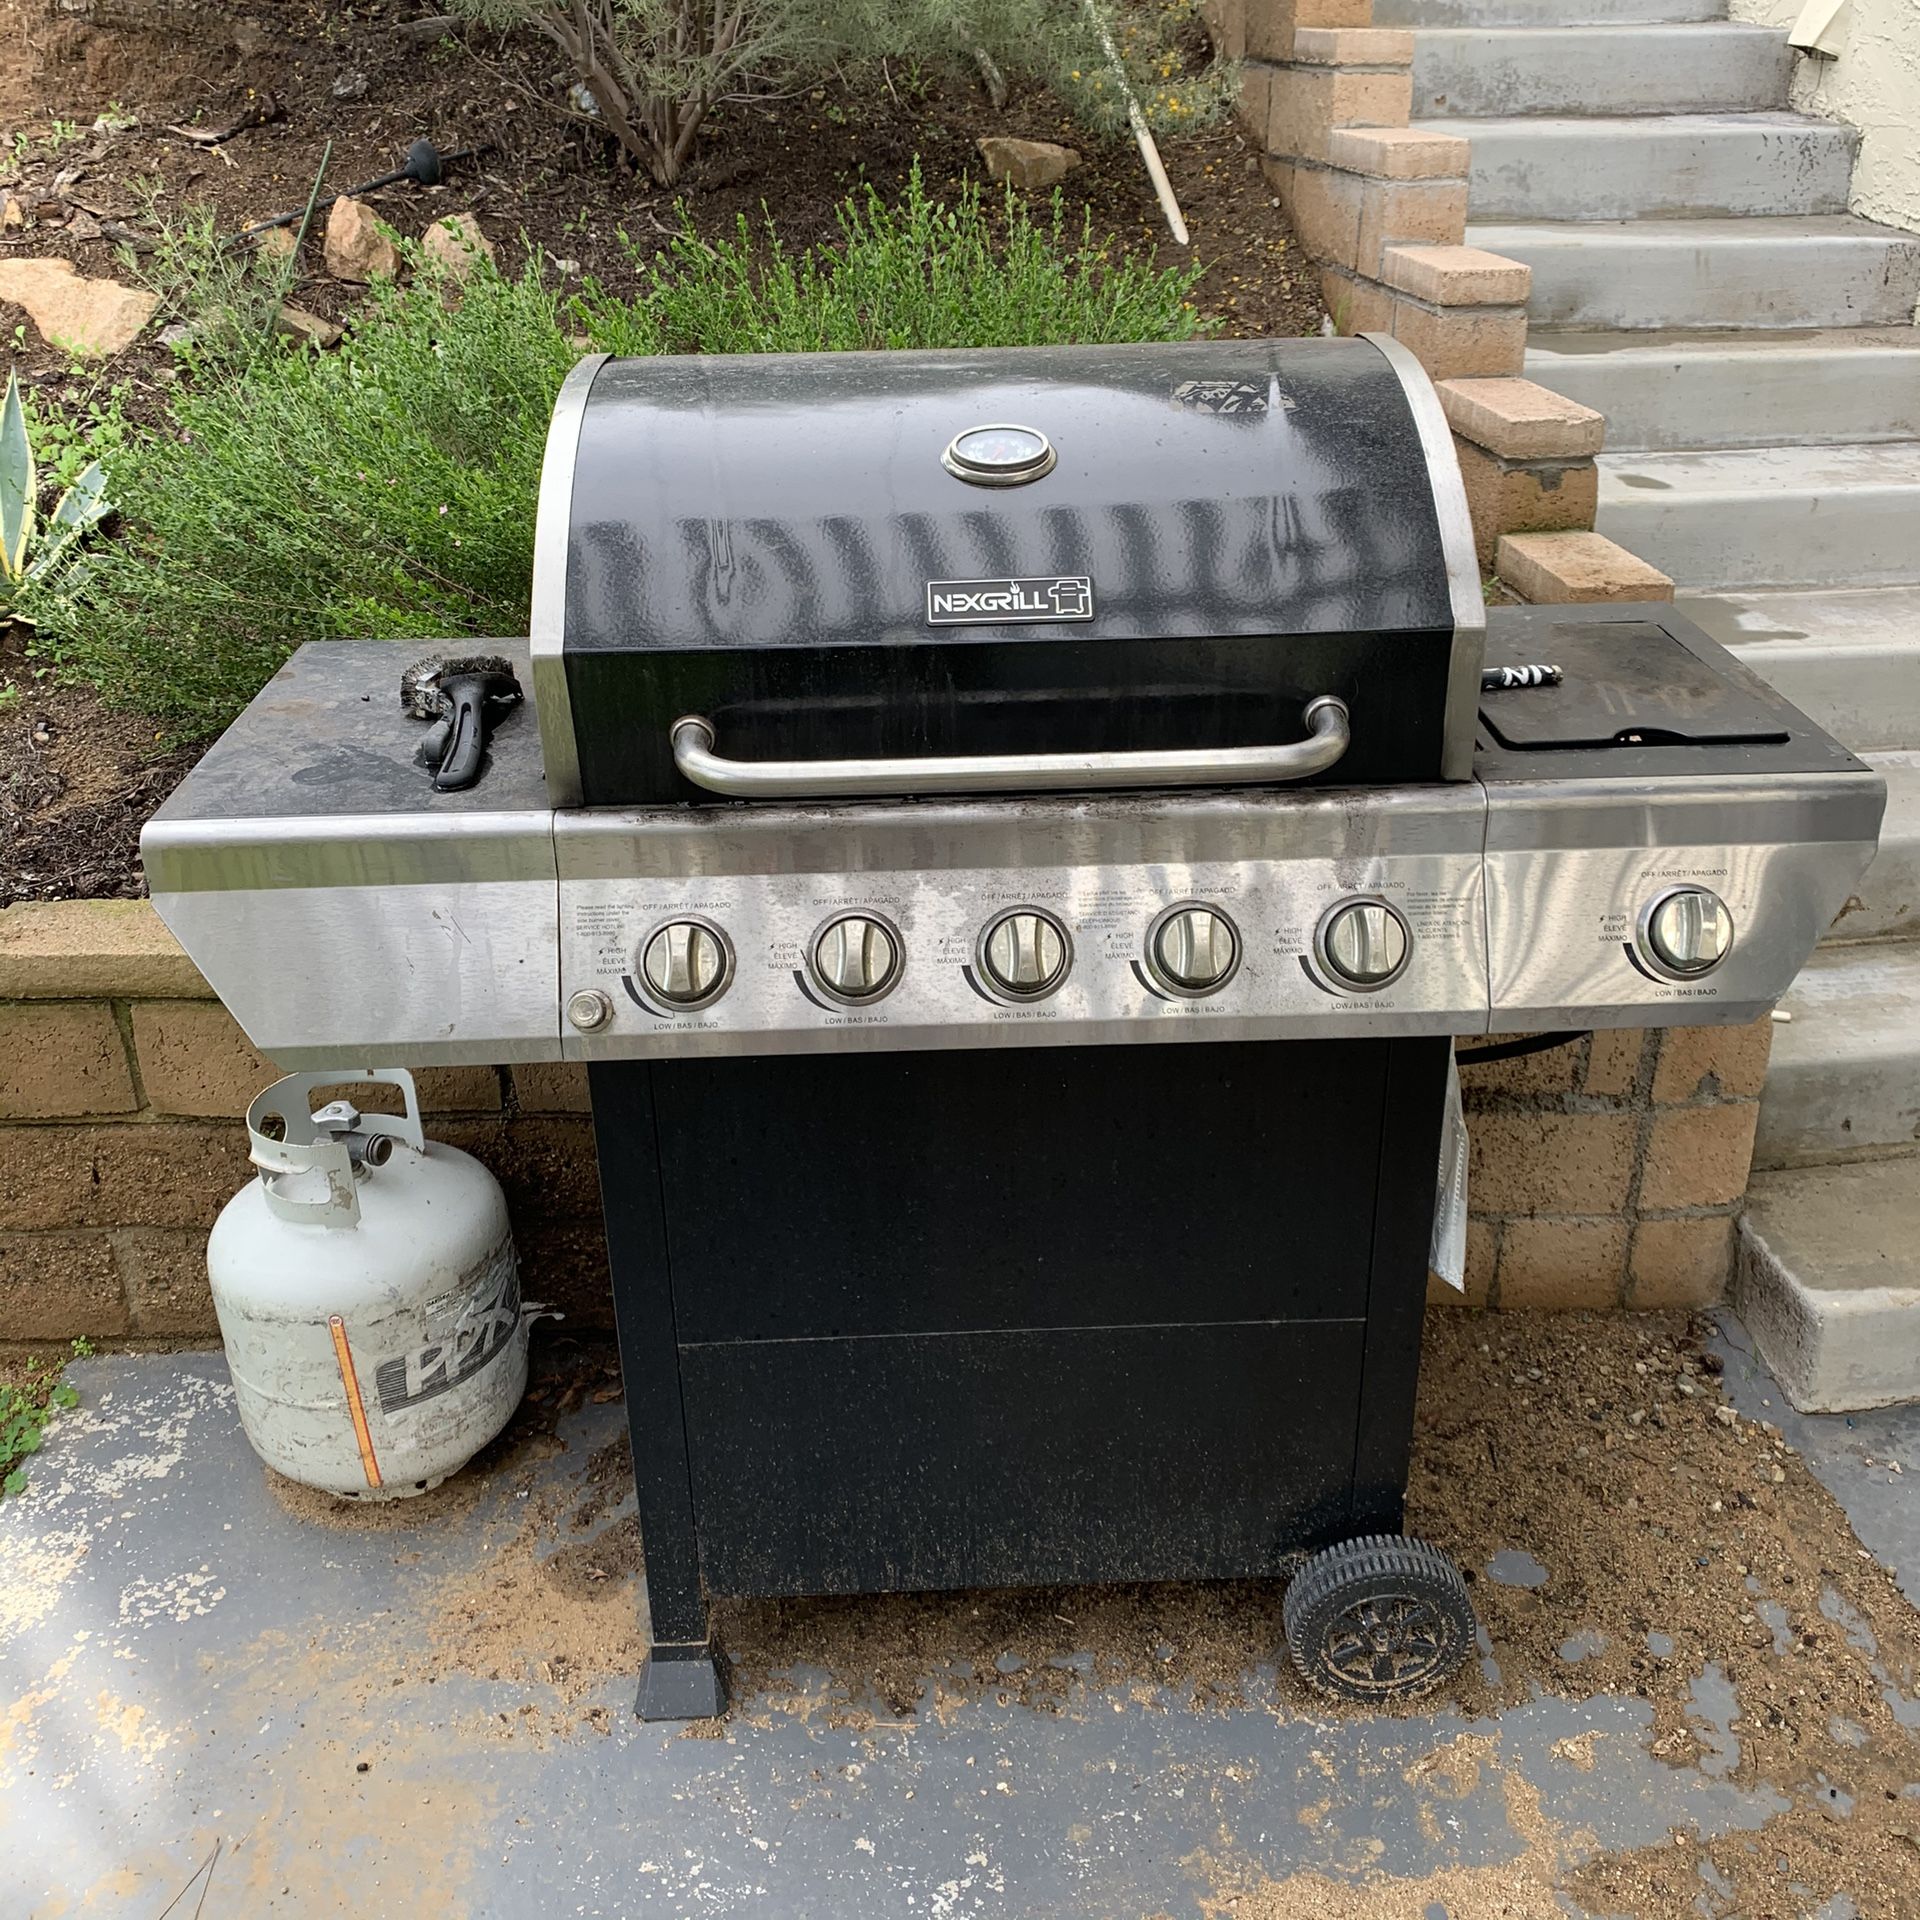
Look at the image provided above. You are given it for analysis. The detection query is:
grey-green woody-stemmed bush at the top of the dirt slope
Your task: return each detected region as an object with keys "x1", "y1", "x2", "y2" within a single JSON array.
[{"x1": 453, "y1": 0, "x2": 1235, "y2": 186}]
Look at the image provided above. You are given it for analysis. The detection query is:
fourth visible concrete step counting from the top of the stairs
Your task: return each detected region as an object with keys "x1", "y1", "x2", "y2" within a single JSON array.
[{"x1": 1467, "y1": 213, "x2": 1920, "y2": 328}]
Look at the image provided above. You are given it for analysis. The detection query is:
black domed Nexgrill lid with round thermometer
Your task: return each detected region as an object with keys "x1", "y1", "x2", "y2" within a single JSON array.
[{"x1": 534, "y1": 340, "x2": 1478, "y2": 803}]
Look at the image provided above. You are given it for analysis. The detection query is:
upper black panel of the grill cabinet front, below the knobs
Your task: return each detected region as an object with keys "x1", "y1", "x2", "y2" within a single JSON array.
[{"x1": 652, "y1": 1041, "x2": 1390, "y2": 1344}]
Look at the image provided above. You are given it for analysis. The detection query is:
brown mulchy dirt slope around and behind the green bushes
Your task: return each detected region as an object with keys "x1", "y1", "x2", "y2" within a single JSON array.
[{"x1": 0, "y1": 0, "x2": 1321, "y2": 906}]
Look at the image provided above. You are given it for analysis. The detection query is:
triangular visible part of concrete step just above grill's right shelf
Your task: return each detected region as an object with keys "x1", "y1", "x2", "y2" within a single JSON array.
[{"x1": 1680, "y1": 588, "x2": 1920, "y2": 753}]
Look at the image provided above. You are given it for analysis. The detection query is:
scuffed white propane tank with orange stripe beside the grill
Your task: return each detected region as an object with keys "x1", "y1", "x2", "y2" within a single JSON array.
[{"x1": 207, "y1": 1068, "x2": 528, "y2": 1500}]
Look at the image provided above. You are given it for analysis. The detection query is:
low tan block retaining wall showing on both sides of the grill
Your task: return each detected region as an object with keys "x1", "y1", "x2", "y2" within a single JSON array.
[{"x1": 0, "y1": 900, "x2": 1770, "y2": 1340}]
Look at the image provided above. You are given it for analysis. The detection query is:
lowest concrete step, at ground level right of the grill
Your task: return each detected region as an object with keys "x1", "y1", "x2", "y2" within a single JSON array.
[{"x1": 1734, "y1": 1156, "x2": 1920, "y2": 1413}]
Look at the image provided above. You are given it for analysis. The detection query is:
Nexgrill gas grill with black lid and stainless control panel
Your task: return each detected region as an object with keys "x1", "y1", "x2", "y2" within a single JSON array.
[{"x1": 144, "y1": 336, "x2": 1884, "y2": 1718}]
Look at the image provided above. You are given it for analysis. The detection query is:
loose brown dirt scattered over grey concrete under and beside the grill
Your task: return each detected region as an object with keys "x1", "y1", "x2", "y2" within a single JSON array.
[{"x1": 259, "y1": 1309, "x2": 1920, "y2": 1920}]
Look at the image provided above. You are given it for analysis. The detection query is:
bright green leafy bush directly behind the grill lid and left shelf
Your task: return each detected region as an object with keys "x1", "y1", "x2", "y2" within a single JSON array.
[{"x1": 29, "y1": 173, "x2": 1200, "y2": 737}]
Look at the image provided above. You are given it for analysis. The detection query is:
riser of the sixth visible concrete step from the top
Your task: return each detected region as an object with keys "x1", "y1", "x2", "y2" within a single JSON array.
[{"x1": 1594, "y1": 486, "x2": 1920, "y2": 588}]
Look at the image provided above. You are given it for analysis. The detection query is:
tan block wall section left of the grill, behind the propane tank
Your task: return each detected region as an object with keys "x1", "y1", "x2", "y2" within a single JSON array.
[{"x1": 0, "y1": 900, "x2": 612, "y2": 1342}]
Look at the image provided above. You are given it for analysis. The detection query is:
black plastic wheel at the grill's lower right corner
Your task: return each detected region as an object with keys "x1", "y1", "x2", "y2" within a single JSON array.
[{"x1": 1281, "y1": 1534, "x2": 1478, "y2": 1701}]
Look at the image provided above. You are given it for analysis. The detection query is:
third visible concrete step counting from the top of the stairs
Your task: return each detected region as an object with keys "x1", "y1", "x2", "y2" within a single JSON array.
[{"x1": 1417, "y1": 113, "x2": 1860, "y2": 221}]
